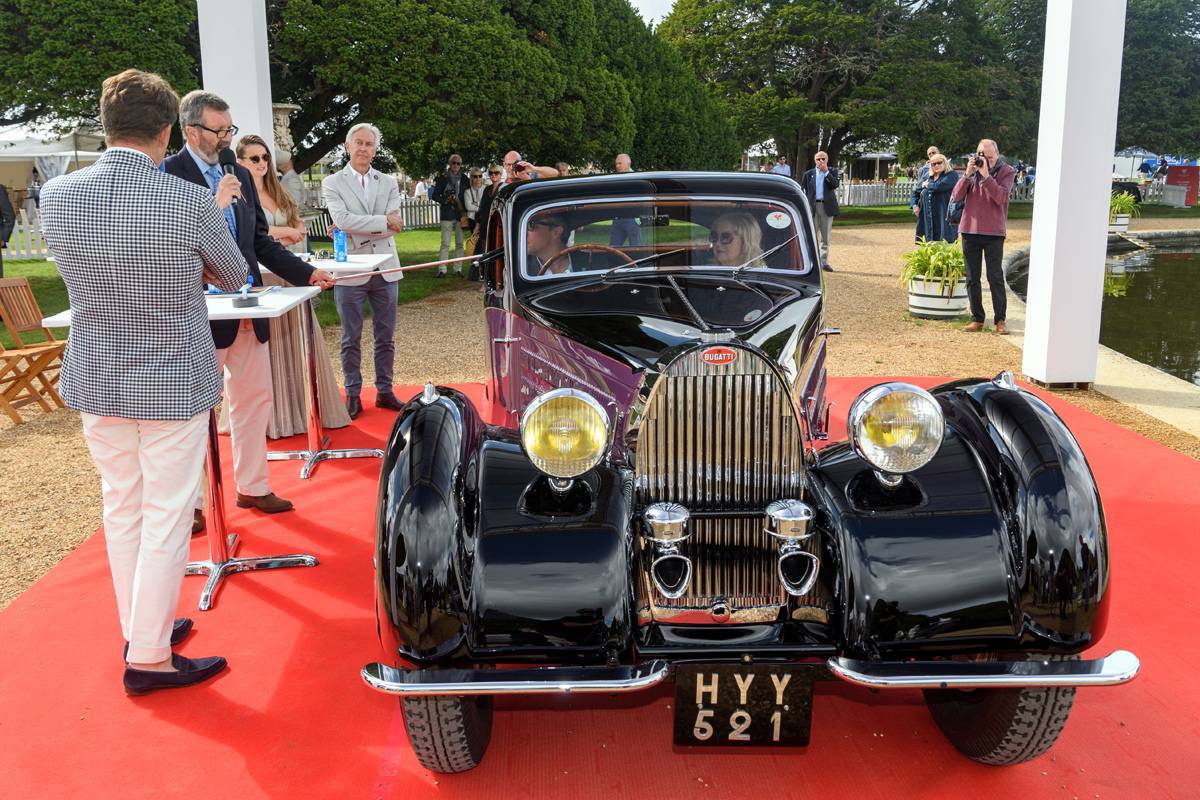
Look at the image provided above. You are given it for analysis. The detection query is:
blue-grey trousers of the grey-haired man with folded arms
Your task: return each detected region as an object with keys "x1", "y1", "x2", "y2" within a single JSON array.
[{"x1": 334, "y1": 275, "x2": 396, "y2": 397}]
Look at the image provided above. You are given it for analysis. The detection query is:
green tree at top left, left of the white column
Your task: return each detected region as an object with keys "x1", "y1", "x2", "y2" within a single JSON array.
[{"x1": 0, "y1": 0, "x2": 198, "y2": 125}]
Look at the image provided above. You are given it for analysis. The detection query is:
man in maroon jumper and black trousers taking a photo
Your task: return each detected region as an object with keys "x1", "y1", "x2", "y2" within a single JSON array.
[{"x1": 950, "y1": 139, "x2": 1016, "y2": 336}]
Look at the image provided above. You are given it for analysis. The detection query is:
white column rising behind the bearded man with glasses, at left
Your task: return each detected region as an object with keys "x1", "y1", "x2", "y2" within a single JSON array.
[{"x1": 197, "y1": 0, "x2": 275, "y2": 146}]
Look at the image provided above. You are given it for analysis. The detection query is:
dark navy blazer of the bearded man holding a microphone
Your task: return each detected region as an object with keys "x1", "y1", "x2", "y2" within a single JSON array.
[{"x1": 162, "y1": 150, "x2": 314, "y2": 350}]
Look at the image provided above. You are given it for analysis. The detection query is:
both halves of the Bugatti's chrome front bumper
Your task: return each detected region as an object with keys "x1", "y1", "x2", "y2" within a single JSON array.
[{"x1": 362, "y1": 650, "x2": 1141, "y2": 696}]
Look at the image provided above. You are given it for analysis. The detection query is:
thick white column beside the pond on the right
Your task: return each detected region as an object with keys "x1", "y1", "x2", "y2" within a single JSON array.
[{"x1": 1022, "y1": 0, "x2": 1126, "y2": 384}]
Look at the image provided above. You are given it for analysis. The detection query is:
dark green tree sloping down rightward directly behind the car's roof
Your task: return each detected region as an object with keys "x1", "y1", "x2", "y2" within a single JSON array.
[{"x1": 594, "y1": 0, "x2": 742, "y2": 170}]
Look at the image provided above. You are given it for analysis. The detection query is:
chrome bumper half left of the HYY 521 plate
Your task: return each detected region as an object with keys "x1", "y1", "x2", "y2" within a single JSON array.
[{"x1": 362, "y1": 661, "x2": 667, "y2": 694}]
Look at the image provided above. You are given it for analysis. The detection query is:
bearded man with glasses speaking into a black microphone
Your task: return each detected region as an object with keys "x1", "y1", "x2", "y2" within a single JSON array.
[{"x1": 162, "y1": 90, "x2": 334, "y2": 533}]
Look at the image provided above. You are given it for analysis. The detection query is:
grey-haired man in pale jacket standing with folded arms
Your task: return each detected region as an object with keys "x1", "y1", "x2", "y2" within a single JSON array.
[{"x1": 320, "y1": 122, "x2": 404, "y2": 420}]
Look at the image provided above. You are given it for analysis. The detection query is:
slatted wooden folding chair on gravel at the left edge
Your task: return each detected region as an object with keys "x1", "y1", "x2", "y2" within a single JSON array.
[{"x1": 0, "y1": 277, "x2": 66, "y2": 421}]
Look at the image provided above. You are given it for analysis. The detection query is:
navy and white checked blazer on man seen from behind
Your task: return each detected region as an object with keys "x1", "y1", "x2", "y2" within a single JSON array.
[{"x1": 41, "y1": 148, "x2": 246, "y2": 420}]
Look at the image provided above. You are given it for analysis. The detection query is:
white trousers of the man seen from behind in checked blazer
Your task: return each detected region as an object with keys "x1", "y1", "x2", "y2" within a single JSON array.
[{"x1": 80, "y1": 411, "x2": 209, "y2": 663}]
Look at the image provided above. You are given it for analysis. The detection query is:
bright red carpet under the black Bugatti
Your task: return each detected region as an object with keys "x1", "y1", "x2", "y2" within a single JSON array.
[{"x1": 0, "y1": 378, "x2": 1200, "y2": 799}]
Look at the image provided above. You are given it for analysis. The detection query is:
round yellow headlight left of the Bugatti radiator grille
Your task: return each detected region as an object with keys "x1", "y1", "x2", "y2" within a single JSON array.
[{"x1": 521, "y1": 389, "x2": 608, "y2": 477}]
